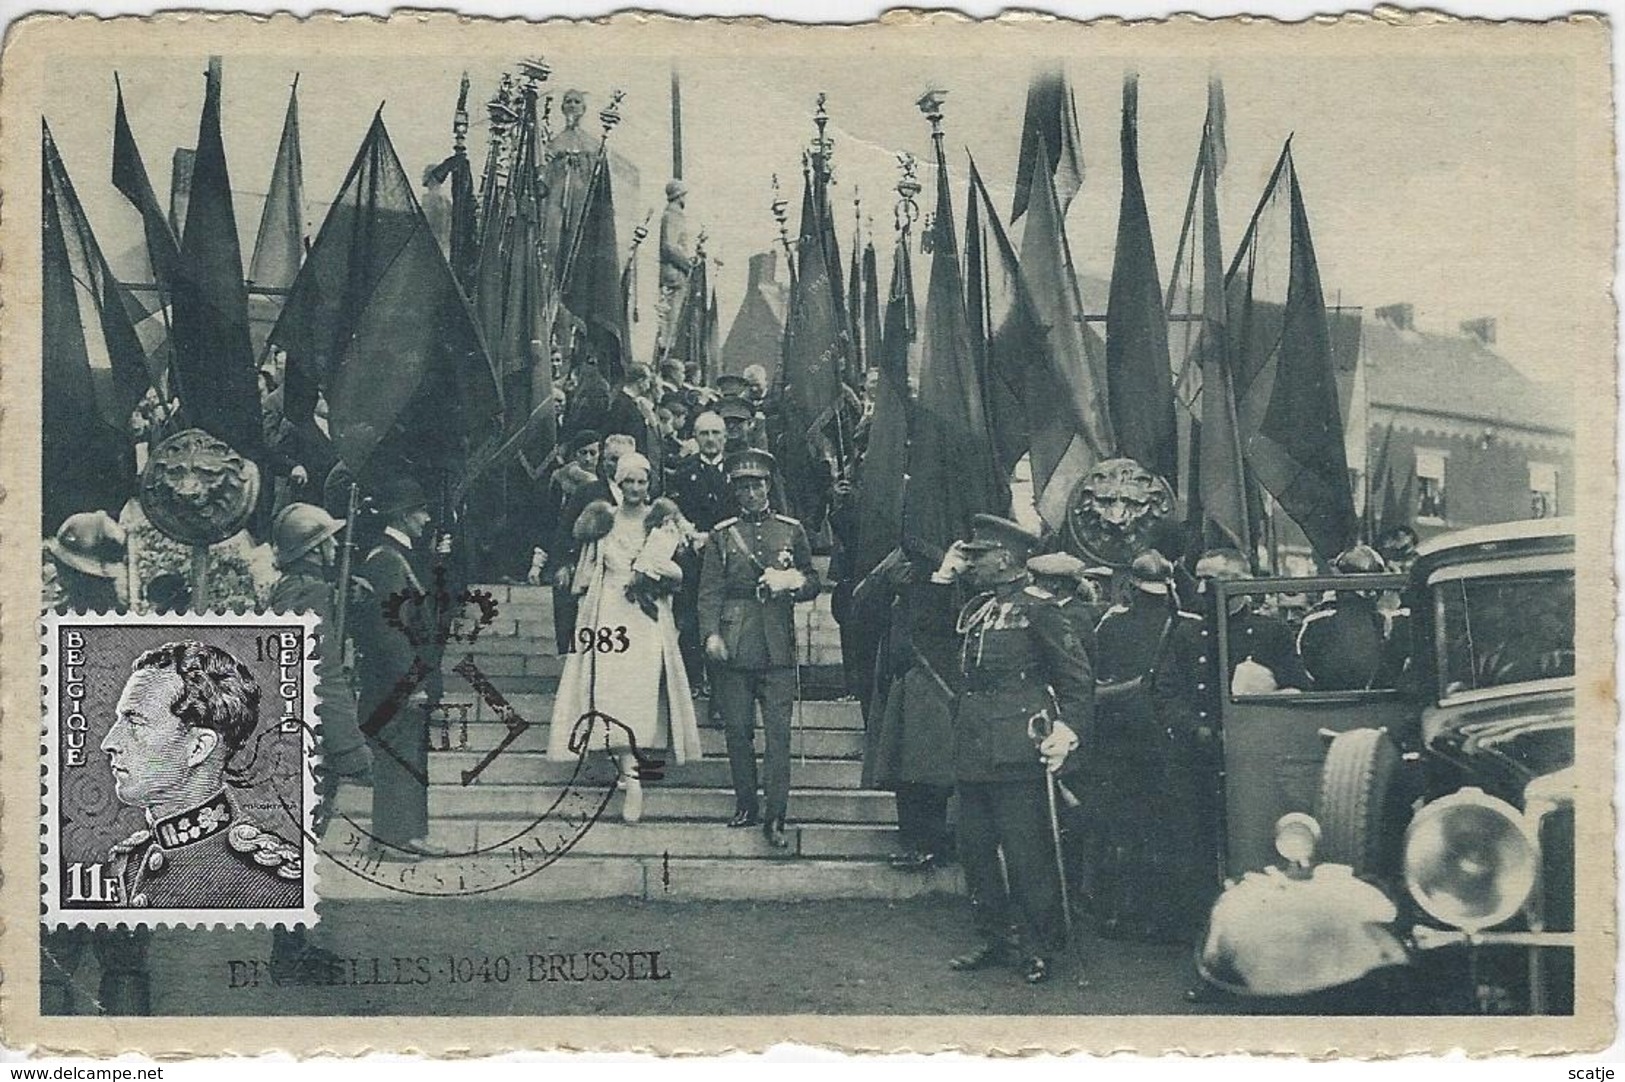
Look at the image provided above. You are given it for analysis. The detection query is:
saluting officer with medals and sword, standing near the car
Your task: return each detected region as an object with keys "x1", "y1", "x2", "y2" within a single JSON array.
[{"x1": 933, "y1": 515, "x2": 1094, "y2": 983}]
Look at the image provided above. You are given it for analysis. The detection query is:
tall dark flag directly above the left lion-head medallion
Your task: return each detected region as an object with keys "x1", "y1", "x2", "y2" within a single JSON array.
[{"x1": 172, "y1": 57, "x2": 263, "y2": 458}]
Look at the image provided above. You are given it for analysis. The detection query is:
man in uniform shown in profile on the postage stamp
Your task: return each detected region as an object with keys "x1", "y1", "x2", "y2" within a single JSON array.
[{"x1": 101, "y1": 642, "x2": 304, "y2": 910}]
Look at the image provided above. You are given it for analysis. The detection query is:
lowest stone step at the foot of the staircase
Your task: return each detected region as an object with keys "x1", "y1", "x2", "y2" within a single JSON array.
[{"x1": 310, "y1": 853, "x2": 964, "y2": 902}]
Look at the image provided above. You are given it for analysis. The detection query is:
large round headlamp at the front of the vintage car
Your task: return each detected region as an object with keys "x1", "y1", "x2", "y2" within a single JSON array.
[{"x1": 1406, "y1": 788, "x2": 1537, "y2": 933}]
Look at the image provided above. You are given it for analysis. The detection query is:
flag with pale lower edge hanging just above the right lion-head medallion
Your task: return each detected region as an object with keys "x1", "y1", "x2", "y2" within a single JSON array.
[{"x1": 1021, "y1": 130, "x2": 1112, "y2": 530}]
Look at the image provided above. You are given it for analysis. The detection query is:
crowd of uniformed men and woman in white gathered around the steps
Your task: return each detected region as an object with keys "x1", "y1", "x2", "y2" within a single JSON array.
[{"x1": 46, "y1": 346, "x2": 1415, "y2": 981}]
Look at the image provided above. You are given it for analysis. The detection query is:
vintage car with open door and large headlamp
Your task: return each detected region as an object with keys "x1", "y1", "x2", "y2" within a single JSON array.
[{"x1": 1199, "y1": 520, "x2": 1575, "y2": 1014}]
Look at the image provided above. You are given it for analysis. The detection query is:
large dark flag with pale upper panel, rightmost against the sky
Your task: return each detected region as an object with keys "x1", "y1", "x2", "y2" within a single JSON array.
[{"x1": 1229, "y1": 140, "x2": 1360, "y2": 560}]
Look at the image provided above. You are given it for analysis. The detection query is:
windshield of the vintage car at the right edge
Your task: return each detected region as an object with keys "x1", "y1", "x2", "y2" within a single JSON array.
[{"x1": 1435, "y1": 570, "x2": 1575, "y2": 699}]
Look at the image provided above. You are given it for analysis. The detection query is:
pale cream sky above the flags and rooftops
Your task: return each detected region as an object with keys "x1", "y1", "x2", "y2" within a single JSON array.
[{"x1": 46, "y1": 46, "x2": 1594, "y2": 377}]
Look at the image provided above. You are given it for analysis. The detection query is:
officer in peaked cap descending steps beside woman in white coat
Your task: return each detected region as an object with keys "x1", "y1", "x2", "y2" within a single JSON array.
[{"x1": 699, "y1": 448, "x2": 819, "y2": 848}]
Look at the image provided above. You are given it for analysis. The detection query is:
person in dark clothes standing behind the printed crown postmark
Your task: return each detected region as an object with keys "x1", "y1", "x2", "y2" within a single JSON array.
[{"x1": 354, "y1": 478, "x2": 444, "y2": 855}]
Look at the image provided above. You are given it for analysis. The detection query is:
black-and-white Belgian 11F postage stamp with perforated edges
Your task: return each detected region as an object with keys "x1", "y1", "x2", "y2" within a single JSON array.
[{"x1": 41, "y1": 612, "x2": 320, "y2": 928}]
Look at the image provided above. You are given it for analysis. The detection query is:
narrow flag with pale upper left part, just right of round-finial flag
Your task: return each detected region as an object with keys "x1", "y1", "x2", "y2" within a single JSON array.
[{"x1": 965, "y1": 158, "x2": 1048, "y2": 476}]
